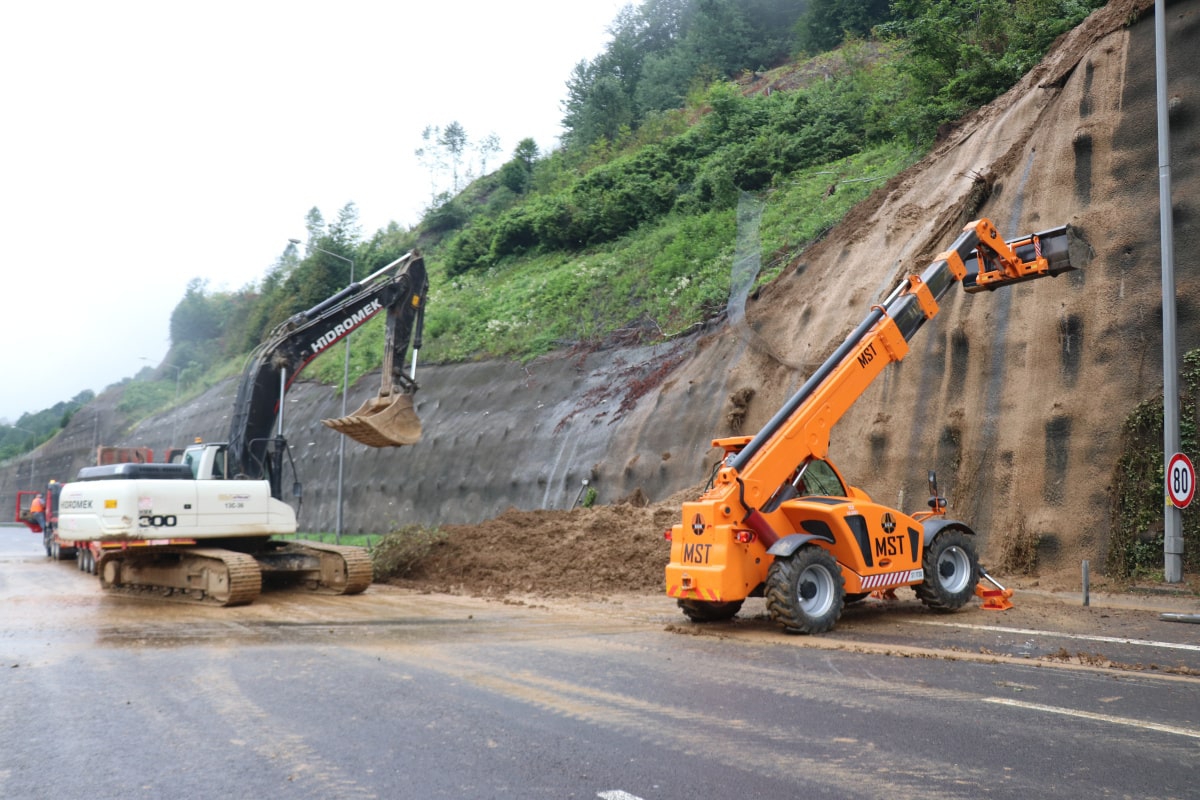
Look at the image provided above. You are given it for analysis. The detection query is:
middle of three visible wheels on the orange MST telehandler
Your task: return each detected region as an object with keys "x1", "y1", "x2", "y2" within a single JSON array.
[{"x1": 767, "y1": 545, "x2": 846, "y2": 633}]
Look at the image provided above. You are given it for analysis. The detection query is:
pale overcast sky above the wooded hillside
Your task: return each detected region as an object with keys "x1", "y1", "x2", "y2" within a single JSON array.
[{"x1": 0, "y1": 0, "x2": 637, "y2": 423}]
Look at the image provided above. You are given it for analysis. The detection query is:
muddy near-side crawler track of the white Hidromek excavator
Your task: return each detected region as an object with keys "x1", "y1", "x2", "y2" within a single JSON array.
[{"x1": 96, "y1": 547, "x2": 263, "y2": 606}]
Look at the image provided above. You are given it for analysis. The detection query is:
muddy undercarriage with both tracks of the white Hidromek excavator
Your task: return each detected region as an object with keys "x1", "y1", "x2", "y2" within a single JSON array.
[{"x1": 96, "y1": 540, "x2": 372, "y2": 606}]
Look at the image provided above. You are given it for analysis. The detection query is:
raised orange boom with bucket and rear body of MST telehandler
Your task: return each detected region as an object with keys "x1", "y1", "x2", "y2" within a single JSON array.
[{"x1": 666, "y1": 219, "x2": 1075, "y2": 603}]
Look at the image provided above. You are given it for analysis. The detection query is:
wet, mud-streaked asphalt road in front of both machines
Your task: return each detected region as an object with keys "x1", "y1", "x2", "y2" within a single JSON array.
[{"x1": 0, "y1": 528, "x2": 1200, "y2": 800}]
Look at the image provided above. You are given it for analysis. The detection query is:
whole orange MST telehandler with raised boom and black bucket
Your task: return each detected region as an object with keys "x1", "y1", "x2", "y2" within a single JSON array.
[{"x1": 666, "y1": 218, "x2": 1081, "y2": 633}]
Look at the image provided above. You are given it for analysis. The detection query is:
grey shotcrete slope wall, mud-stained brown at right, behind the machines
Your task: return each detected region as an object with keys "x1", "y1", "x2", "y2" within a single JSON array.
[{"x1": 4, "y1": 0, "x2": 1200, "y2": 594}]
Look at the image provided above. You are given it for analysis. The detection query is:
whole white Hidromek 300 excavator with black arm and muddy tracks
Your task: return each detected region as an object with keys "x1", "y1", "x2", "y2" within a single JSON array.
[{"x1": 50, "y1": 251, "x2": 428, "y2": 606}]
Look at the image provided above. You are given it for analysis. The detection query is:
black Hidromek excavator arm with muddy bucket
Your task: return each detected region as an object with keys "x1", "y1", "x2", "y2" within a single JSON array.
[{"x1": 229, "y1": 251, "x2": 428, "y2": 498}]
